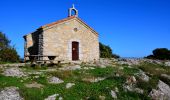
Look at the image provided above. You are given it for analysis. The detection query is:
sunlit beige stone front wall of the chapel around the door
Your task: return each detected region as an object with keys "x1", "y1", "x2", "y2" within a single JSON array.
[{"x1": 43, "y1": 18, "x2": 99, "y2": 61}]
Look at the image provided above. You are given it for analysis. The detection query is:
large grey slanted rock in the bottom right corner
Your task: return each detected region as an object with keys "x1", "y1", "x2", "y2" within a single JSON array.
[{"x1": 149, "y1": 81, "x2": 170, "y2": 100}]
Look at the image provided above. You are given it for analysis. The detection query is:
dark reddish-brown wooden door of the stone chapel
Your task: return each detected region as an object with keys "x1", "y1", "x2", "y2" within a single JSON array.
[{"x1": 72, "y1": 41, "x2": 79, "y2": 60}]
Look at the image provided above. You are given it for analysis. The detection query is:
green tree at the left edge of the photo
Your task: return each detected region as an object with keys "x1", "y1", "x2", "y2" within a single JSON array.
[{"x1": 0, "y1": 32, "x2": 19, "y2": 62}]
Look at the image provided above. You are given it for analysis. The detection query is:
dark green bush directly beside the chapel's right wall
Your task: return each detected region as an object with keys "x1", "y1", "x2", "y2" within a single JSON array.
[{"x1": 99, "y1": 43, "x2": 119, "y2": 58}]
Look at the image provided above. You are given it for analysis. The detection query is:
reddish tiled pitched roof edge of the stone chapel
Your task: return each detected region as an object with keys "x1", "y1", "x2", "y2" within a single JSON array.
[{"x1": 25, "y1": 16, "x2": 98, "y2": 36}]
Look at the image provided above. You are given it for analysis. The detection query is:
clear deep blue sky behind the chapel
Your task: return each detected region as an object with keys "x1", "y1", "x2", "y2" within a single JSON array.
[{"x1": 0, "y1": 0, "x2": 170, "y2": 57}]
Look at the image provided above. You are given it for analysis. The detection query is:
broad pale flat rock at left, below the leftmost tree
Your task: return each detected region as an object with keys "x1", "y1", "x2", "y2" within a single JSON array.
[{"x1": 3, "y1": 67, "x2": 26, "y2": 78}]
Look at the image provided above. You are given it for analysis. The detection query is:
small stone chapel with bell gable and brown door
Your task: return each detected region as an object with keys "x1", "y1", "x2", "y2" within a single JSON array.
[{"x1": 24, "y1": 5, "x2": 99, "y2": 62}]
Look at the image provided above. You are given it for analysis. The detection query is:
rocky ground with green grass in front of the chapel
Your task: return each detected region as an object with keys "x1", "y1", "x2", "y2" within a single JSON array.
[{"x1": 0, "y1": 59, "x2": 170, "y2": 100}]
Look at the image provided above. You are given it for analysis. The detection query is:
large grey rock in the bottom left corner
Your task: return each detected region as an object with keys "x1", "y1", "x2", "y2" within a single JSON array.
[{"x1": 0, "y1": 87, "x2": 24, "y2": 100}]
